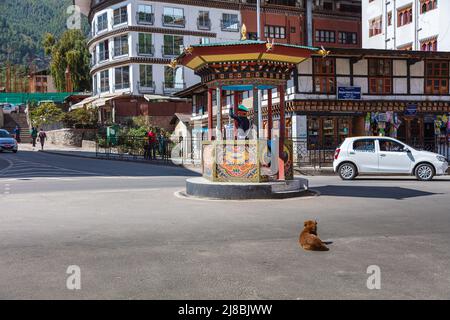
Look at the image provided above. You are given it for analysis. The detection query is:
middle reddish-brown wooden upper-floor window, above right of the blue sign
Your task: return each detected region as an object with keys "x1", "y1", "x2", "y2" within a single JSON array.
[{"x1": 369, "y1": 59, "x2": 392, "y2": 94}]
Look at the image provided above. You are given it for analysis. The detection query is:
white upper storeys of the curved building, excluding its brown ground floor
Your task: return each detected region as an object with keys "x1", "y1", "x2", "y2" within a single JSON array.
[{"x1": 84, "y1": 0, "x2": 241, "y2": 95}]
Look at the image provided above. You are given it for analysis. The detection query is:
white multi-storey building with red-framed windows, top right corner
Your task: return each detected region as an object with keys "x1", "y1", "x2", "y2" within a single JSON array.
[{"x1": 362, "y1": 0, "x2": 450, "y2": 51}]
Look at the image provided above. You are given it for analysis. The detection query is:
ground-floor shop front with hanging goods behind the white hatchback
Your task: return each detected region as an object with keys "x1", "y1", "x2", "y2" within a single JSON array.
[{"x1": 286, "y1": 100, "x2": 450, "y2": 165}]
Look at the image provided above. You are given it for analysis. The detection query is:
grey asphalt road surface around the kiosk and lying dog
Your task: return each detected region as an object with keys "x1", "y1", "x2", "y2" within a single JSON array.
[{"x1": 0, "y1": 152, "x2": 450, "y2": 299}]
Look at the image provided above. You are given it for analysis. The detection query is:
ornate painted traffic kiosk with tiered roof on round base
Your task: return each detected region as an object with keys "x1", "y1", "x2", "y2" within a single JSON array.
[{"x1": 175, "y1": 30, "x2": 326, "y2": 199}]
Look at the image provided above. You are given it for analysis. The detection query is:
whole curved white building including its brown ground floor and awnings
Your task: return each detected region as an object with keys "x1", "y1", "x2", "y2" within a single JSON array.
[{"x1": 74, "y1": 0, "x2": 242, "y2": 128}]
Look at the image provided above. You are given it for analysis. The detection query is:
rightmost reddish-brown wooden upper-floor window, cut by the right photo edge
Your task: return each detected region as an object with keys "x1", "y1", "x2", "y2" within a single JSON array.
[{"x1": 425, "y1": 60, "x2": 449, "y2": 95}]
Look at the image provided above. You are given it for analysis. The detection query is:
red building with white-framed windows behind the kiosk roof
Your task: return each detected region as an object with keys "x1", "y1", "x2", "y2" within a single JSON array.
[{"x1": 241, "y1": 0, "x2": 361, "y2": 48}]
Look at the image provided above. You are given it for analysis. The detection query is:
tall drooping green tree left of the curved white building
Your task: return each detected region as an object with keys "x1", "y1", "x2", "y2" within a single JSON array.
[{"x1": 42, "y1": 30, "x2": 91, "y2": 91}]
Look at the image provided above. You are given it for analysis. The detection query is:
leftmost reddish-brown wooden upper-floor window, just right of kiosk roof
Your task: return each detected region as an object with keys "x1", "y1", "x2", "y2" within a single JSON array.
[{"x1": 313, "y1": 58, "x2": 336, "y2": 94}]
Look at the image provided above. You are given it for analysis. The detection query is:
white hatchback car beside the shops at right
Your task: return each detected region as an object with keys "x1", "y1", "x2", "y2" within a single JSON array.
[{"x1": 333, "y1": 137, "x2": 448, "y2": 181}]
